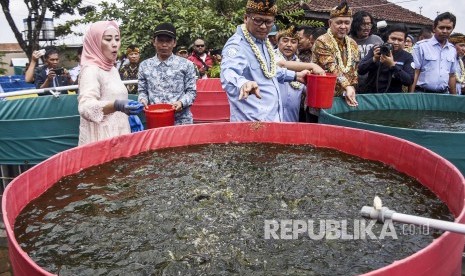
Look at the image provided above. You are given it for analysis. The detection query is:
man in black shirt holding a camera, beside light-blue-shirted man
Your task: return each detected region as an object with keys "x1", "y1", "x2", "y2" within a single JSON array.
[{"x1": 358, "y1": 24, "x2": 414, "y2": 93}]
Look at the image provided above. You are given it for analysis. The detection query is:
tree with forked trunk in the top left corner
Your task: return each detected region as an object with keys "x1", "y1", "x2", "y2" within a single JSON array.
[{"x1": 0, "y1": 0, "x2": 94, "y2": 57}]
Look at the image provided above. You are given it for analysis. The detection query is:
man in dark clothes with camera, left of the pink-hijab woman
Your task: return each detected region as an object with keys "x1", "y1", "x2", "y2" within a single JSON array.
[{"x1": 34, "y1": 47, "x2": 72, "y2": 92}]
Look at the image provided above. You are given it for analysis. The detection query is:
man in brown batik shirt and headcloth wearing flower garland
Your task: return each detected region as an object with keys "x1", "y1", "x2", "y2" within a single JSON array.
[{"x1": 312, "y1": 1, "x2": 359, "y2": 106}]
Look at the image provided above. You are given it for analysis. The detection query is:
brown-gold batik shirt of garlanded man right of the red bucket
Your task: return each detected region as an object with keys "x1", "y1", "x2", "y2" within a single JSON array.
[{"x1": 312, "y1": 33, "x2": 359, "y2": 96}]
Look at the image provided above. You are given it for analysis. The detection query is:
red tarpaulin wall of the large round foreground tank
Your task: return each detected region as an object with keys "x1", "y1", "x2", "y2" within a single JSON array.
[{"x1": 2, "y1": 122, "x2": 465, "y2": 275}]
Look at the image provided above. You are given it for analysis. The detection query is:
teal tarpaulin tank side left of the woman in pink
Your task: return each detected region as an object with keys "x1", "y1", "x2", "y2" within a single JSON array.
[{"x1": 0, "y1": 95, "x2": 140, "y2": 165}]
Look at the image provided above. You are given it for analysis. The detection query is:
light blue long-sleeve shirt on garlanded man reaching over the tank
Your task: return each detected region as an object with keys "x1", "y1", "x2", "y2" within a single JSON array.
[{"x1": 221, "y1": 26, "x2": 295, "y2": 122}]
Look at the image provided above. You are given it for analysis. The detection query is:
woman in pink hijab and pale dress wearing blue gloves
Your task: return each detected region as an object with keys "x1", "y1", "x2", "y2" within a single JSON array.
[{"x1": 78, "y1": 21, "x2": 143, "y2": 145}]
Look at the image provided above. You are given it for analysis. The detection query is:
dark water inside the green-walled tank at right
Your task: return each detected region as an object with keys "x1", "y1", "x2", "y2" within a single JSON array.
[{"x1": 334, "y1": 110, "x2": 465, "y2": 132}]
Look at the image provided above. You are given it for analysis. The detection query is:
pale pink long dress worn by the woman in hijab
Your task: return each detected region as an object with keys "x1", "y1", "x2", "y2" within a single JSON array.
[{"x1": 78, "y1": 65, "x2": 131, "y2": 145}]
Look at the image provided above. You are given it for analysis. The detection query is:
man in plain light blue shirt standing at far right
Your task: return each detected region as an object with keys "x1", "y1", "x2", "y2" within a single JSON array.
[{"x1": 409, "y1": 12, "x2": 457, "y2": 94}]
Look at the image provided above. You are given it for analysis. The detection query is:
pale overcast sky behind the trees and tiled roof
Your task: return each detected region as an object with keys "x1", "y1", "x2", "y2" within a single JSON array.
[{"x1": 0, "y1": 0, "x2": 465, "y2": 44}]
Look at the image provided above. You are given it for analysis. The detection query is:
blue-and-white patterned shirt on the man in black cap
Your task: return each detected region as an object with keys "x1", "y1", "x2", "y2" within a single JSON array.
[{"x1": 138, "y1": 54, "x2": 197, "y2": 125}]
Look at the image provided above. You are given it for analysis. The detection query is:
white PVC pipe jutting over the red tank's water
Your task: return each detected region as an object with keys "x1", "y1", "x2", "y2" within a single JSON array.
[{"x1": 360, "y1": 206, "x2": 465, "y2": 234}]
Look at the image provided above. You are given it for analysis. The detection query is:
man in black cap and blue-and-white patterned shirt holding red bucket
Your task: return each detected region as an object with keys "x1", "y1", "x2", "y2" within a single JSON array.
[{"x1": 138, "y1": 23, "x2": 197, "y2": 125}]
